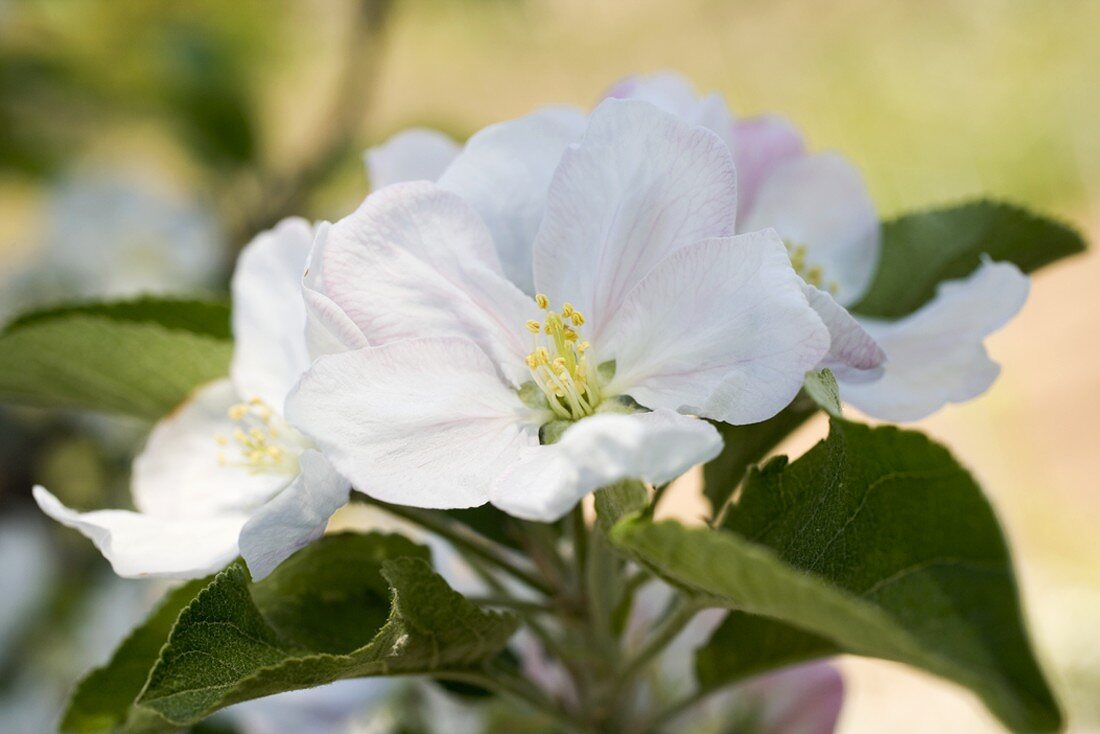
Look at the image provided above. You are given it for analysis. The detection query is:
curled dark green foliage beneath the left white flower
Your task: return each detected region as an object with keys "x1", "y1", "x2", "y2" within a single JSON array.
[{"x1": 64, "y1": 534, "x2": 516, "y2": 733}]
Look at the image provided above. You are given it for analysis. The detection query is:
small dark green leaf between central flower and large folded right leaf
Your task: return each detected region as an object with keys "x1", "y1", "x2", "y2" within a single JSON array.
[{"x1": 703, "y1": 393, "x2": 820, "y2": 512}]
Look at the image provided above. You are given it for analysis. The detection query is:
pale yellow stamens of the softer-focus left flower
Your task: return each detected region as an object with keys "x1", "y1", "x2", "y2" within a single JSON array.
[{"x1": 215, "y1": 397, "x2": 299, "y2": 474}]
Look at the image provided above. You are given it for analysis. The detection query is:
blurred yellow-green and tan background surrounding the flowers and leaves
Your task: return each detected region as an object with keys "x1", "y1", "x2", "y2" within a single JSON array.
[{"x1": 0, "y1": 0, "x2": 1100, "y2": 734}]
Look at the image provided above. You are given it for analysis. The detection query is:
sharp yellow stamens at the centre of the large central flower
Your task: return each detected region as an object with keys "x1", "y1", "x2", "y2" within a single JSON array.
[{"x1": 527, "y1": 293, "x2": 600, "y2": 420}]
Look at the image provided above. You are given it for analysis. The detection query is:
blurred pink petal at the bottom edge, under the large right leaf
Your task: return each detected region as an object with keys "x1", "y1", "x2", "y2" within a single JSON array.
[{"x1": 738, "y1": 662, "x2": 844, "y2": 734}]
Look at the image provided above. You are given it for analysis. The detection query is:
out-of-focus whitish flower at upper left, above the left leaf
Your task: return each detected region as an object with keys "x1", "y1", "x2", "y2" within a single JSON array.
[{"x1": 2, "y1": 169, "x2": 222, "y2": 323}]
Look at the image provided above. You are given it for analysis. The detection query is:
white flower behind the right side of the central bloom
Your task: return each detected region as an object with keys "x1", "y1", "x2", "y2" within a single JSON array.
[{"x1": 611, "y1": 74, "x2": 1029, "y2": 420}]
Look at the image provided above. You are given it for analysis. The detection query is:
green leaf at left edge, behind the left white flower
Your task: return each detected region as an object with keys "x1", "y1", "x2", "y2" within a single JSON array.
[{"x1": 0, "y1": 298, "x2": 233, "y2": 419}]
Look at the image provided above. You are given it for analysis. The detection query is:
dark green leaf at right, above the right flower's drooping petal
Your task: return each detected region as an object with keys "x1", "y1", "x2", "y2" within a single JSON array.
[{"x1": 851, "y1": 201, "x2": 1085, "y2": 319}]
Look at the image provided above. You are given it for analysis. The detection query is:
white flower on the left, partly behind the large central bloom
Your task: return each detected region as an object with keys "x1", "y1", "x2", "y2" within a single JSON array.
[{"x1": 34, "y1": 219, "x2": 349, "y2": 579}]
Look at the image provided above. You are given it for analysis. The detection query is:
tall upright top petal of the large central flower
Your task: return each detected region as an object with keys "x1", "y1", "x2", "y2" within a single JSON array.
[{"x1": 535, "y1": 99, "x2": 737, "y2": 341}]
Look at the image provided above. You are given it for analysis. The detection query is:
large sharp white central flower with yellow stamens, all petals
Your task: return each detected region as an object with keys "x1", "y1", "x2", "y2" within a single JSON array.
[{"x1": 287, "y1": 100, "x2": 828, "y2": 521}]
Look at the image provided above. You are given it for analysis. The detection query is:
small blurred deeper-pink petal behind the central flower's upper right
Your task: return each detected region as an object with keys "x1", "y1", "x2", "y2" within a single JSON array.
[{"x1": 733, "y1": 114, "x2": 806, "y2": 221}]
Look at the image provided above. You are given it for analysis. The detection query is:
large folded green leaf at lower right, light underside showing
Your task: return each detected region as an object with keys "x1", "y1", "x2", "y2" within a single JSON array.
[{"x1": 612, "y1": 419, "x2": 1062, "y2": 732}]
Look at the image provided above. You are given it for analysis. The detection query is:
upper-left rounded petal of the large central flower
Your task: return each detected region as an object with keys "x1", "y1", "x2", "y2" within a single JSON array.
[{"x1": 320, "y1": 183, "x2": 538, "y2": 382}]
